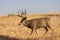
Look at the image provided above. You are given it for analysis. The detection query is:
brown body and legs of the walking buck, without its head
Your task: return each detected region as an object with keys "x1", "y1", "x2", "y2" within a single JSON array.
[{"x1": 21, "y1": 18, "x2": 51, "y2": 35}]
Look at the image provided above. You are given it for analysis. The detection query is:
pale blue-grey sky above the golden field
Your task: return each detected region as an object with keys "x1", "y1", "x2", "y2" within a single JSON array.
[{"x1": 0, "y1": 0, "x2": 60, "y2": 15}]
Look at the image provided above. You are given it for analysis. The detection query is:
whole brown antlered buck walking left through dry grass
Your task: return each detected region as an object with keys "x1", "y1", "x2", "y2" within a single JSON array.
[{"x1": 18, "y1": 10, "x2": 53, "y2": 35}]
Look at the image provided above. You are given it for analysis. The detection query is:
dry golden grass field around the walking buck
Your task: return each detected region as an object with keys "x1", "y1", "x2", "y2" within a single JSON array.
[{"x1": 0, "y1": 14, "x2": 60, "y2": 40}]
